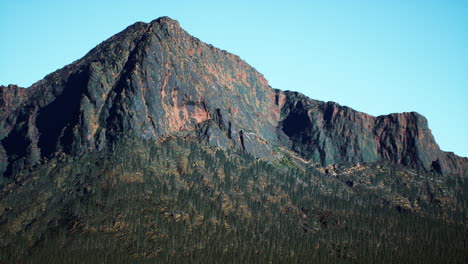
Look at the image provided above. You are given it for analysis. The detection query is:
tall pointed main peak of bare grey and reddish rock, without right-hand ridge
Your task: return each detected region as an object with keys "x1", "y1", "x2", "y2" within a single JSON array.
[{"x1": 1, "y1": 17, "x2": 279, "y2": 179}]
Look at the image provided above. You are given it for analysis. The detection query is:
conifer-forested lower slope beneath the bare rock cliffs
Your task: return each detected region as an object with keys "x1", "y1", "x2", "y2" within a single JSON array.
[{"x1": 0, "y1": 139, "x2": 468, "y2": 263}]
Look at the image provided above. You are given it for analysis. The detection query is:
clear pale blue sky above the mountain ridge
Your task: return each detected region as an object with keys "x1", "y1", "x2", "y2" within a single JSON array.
[{"x1": 0, "y1": 0, "x2": 468, "y2": 157}]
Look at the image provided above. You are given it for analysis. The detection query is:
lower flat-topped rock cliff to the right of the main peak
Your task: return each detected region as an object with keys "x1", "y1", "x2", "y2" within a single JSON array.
[{"x1": 280, "y1": 91, "x2": 468, "y2": 174}]
